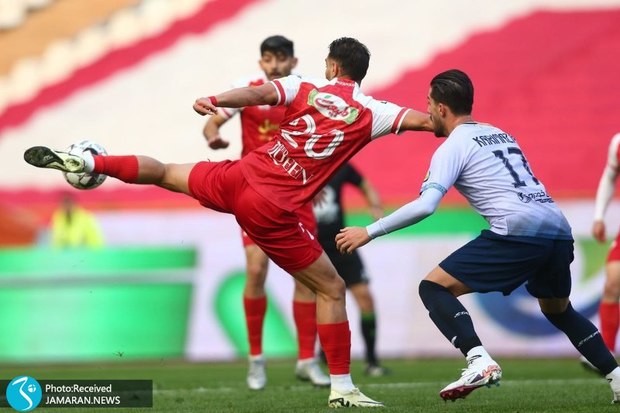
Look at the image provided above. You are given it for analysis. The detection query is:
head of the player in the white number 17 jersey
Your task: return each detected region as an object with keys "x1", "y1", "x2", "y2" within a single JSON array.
[{"x1": 427, "y1": 69, "x2": 474, "y2": 136}]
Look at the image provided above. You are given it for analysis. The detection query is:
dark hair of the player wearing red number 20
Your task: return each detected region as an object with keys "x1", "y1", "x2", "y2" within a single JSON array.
[{"x1": 327, "y1": 37, "x2": 370, "y2": 83}]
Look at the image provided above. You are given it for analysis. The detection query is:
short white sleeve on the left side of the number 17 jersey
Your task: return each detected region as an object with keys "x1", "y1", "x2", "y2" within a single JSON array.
[{"x1": 420, "y1": 137, "x2": 469, "y2": 195}]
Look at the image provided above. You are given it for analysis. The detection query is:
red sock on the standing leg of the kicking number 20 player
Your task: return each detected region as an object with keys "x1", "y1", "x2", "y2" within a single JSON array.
[{"x1": 316, "y1": 321, "x2": 351, "y2": 374}]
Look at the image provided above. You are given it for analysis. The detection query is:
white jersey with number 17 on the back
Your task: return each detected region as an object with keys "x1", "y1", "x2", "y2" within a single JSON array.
[{"x1": 421, "y1": 122, "x2": 572, "y2": 239}]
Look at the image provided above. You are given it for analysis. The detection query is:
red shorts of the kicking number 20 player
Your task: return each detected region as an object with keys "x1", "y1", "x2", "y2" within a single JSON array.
[{"x1": 188, "y1": 161, "x2": 323, "y2": 273}]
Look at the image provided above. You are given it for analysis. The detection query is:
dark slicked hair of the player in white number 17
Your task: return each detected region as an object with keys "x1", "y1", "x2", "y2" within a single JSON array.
[{"x1": 431, "y1": 69, "x2": 474, "y2": 115}]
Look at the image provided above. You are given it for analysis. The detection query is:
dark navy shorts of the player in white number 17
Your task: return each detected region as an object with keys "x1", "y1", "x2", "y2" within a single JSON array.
[{"x1": 439, "y1": 230, "x2": 574, "y2": 298}]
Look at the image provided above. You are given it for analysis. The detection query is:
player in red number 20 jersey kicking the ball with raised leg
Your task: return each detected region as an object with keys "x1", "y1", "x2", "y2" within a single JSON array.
[{"x1": 24, "y1": 37, "x2": 432, "y2": 407}]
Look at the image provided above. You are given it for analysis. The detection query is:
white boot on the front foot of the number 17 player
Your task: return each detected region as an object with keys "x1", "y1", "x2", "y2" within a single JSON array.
[{"x1": 439, "y1": 355, "x2": 502, "y2": 401}]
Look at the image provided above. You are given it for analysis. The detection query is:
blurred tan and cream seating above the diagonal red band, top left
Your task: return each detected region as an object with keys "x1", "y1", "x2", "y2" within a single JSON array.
[{"x1": 0, "y1": 0, "x2": 205, "y2": 112}]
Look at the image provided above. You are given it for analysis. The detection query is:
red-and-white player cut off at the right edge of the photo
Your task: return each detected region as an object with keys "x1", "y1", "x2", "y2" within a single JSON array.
[{"x1": 582, "y1": 133, "x2": 620, "y2": 361}]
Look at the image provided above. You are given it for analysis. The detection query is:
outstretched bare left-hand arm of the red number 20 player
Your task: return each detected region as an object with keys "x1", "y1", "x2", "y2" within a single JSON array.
[{"x1": 194, "y1": 82, "x2": 278, "y2": 116}]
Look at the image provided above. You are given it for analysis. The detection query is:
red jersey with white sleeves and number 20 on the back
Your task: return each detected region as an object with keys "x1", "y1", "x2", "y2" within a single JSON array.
[{"x1": 240, "y1": 75, "x2": 408, "y2": 211}]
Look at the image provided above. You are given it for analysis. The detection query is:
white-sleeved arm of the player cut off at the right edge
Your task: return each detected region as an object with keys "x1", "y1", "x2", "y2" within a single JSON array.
[{"x1": 592, "y1": 135, "x2": 620, "y2": 242}]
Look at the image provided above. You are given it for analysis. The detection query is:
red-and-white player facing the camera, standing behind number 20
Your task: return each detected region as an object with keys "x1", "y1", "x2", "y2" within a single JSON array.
[{"x1": 203, "y1": 35, "x2": 329, "y2": 390}]
